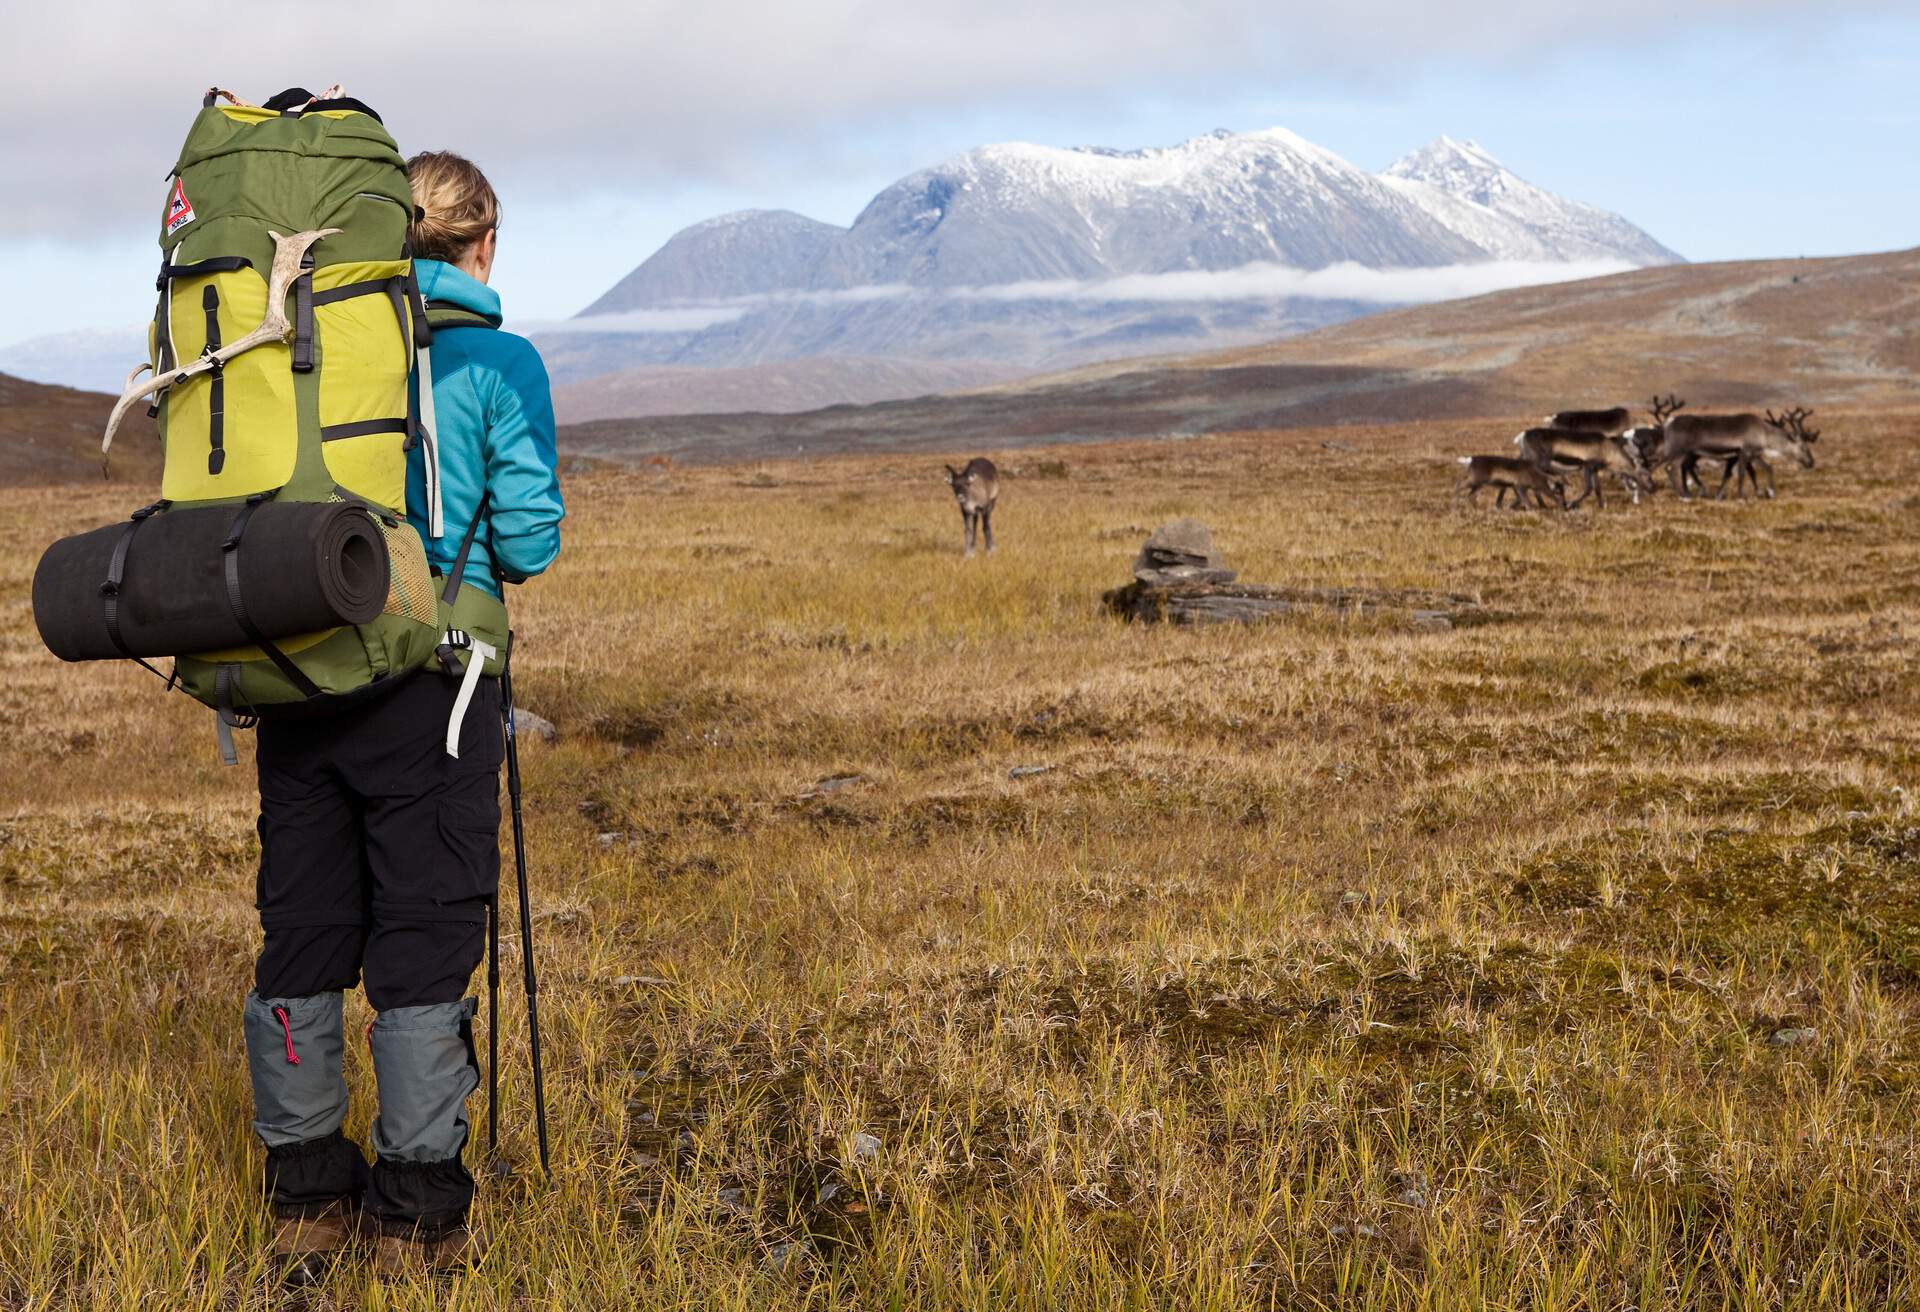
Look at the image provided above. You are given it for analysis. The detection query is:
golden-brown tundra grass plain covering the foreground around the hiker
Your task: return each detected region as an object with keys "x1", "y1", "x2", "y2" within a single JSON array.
[{"x1": 0, "y1": 415, "x2": 1920, "y2": 1312}]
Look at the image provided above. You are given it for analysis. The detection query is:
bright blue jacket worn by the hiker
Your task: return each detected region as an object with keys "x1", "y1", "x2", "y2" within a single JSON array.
[{"x1": 407, "y1": 259, "x2": 566, "y2": 597}]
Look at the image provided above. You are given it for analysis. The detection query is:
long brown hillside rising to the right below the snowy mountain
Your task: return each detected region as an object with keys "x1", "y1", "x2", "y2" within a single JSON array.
[{"x1": 563, "y1": 250, "x2": 1920, "y2": 461}]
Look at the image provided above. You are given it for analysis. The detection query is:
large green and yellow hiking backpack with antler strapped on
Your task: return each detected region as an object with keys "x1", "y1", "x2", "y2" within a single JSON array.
[{"x1": 102, "y1": 90, "x2": 507, "y2": 761}]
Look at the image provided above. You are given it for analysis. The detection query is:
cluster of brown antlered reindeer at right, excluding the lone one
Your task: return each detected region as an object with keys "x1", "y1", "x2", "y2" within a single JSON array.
[{"x1": 1459, "y1": 394, "x2": 1820, "y2": 511}]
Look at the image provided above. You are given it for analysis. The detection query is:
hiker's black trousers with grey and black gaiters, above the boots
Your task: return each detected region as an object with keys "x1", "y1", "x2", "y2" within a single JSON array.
[{"x1": 248, "y1": 670, "x2": 505, "y2": 1235}]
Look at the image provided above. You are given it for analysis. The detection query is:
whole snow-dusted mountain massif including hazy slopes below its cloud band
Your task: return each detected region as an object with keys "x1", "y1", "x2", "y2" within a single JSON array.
[{"x1": 538, "y1": 129, "x2": 1680, "y2": 403}]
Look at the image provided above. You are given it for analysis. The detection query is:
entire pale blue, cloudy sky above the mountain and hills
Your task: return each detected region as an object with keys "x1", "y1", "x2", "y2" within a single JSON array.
[{"x1": 0, "y1": 0, "x2": 1920, "y2": 353}]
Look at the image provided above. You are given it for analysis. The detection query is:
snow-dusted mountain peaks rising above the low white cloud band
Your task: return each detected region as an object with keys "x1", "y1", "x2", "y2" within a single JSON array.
[{"x1": 586, "y1": 129, "x2": 1678, "y2": 315}]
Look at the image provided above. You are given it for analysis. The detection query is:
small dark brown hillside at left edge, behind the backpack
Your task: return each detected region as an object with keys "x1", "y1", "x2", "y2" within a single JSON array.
[{"x1": 0, "y1": 373, "x2": 159, "y2": 487}]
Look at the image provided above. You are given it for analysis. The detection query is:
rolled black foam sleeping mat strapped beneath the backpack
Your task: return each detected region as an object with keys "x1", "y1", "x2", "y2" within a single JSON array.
[{"x1": 33, "y1": 501, "x2": 392, "y2": 661}]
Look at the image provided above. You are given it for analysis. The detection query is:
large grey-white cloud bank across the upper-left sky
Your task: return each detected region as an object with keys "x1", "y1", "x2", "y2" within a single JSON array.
[{"x1": 0, "y1": 0, "x2": 1889, "y2": 236}]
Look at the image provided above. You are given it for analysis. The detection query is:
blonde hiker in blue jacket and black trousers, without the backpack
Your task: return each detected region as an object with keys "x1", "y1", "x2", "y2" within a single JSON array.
[{"x1": 246, "y1": 152, "x2": 564, "y2": 1285}]
